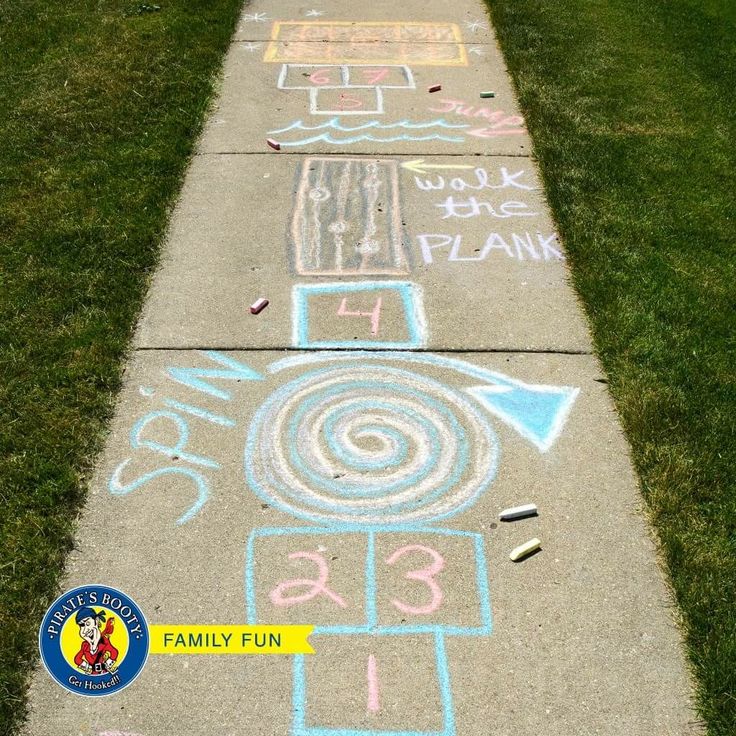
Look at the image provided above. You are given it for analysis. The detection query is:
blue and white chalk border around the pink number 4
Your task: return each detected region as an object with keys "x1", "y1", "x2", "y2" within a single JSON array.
[{"x1": 292, "y1": 281, "x2": 427, "y2": 350}]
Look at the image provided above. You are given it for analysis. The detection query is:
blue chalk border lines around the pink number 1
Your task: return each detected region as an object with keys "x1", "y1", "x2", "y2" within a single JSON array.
[{"x1": 291, "y1": 632, "x2": 456, "y2": 736}]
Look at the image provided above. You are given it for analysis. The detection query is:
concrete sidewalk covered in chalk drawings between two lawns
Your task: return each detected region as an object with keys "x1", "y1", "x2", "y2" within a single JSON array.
[{"x1": 26, "y1": 0, "x2": 700, "y2": 736}]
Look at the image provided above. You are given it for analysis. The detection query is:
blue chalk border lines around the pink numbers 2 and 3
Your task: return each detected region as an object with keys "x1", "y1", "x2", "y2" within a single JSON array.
[{"x1": 245, "y1": 526, "x2": 493, "y2": 636}]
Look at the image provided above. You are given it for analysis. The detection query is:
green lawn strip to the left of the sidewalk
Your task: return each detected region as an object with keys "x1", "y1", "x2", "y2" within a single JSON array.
[{"x1": 0, "y1": 0, "x2": 241, "y2": 734}]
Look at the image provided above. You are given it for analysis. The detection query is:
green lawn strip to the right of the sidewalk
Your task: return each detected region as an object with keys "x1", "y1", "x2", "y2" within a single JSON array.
[{"x1": 489, "y1": 0, "x2": 736, "y2": 736}]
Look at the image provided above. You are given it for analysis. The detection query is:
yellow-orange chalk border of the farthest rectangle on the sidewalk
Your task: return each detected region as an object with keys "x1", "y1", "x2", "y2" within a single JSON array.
[{"x1": 263, "y1": 20, "x2": 468, "y2": 66}]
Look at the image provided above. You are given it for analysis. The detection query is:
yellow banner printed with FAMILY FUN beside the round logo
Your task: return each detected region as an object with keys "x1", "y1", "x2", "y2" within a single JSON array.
[{"x1": 148, "y1": 624, "x2": 314, "y2": 654}]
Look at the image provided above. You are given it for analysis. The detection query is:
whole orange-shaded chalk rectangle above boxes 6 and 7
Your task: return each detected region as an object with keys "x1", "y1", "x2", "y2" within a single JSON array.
[{"x1": 263, "y1": 21, "x2": 468, "y2": 66}]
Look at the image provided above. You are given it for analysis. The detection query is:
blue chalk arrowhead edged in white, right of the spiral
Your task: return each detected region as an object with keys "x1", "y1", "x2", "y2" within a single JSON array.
[{"x1": 465, "y1": 377, "x2": 580, "y2": 452}]
